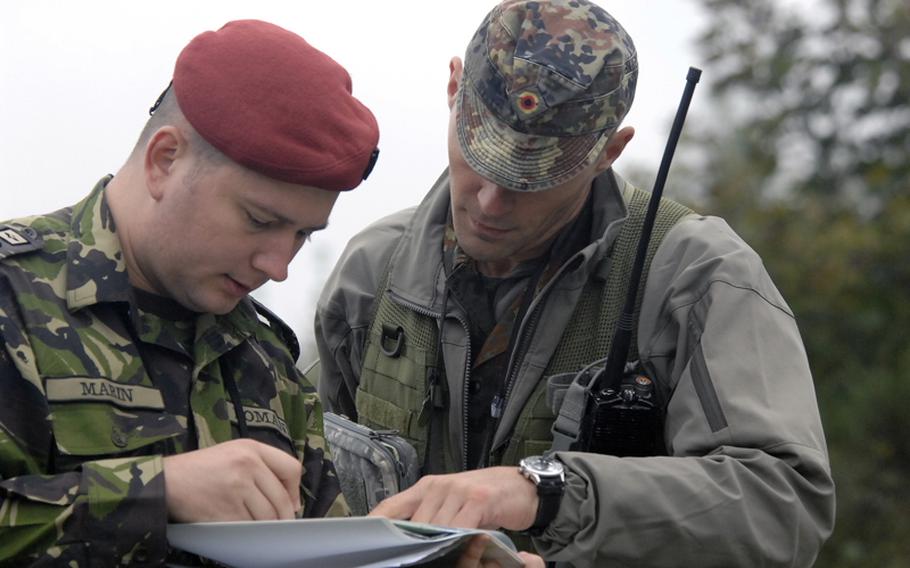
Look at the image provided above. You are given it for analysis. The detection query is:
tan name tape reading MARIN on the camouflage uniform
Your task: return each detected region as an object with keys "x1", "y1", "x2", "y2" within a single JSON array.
[{"x1": 44, "y1": 377, "x2": 164, "y2": 410}]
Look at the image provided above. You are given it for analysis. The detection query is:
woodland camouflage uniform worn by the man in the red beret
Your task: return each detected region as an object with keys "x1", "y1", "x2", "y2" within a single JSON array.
[{"x1": 0, "y1": 180, "x2": 347, "y2": 566}]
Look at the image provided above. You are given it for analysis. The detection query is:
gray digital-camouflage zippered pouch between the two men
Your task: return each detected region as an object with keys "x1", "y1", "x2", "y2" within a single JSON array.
[{"x1": 323, "y1": 412, "x2": 420, "y2": 516}]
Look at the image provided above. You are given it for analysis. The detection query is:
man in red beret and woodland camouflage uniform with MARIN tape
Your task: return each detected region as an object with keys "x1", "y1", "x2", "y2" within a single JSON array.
[{"x1": 0, "y1": 21, "x2": 379, "y2": 566}]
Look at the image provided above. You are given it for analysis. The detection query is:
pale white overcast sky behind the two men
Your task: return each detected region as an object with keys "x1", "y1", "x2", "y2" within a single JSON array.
[{"x1": 0, "y1": 0, "x2": 705, "y2": 356}]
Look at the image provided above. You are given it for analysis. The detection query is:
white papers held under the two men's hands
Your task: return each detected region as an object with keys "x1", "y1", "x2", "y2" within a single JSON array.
[{"x1": 167, "y1": 517, "x2": 522, "y2": 568}]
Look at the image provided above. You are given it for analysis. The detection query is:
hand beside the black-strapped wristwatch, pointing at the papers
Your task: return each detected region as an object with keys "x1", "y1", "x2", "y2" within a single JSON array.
[{"x1": 370, "y1": 467, "x2": 538, "y2": 530}]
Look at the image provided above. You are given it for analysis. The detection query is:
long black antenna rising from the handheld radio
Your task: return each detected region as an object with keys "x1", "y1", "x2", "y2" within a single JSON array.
[{"x1": 591, "y1": 67, "x2": 701, "y2": 393}]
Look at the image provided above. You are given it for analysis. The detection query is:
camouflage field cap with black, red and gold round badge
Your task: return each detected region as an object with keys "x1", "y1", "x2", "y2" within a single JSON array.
[{"x1": 456, "y1": 0, "x2": 638, "y2": 191}]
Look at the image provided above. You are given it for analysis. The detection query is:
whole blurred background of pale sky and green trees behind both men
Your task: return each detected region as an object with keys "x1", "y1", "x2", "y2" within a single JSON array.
[{"x1": 0, "y1": 0, "x2": 910, "y2": 568}]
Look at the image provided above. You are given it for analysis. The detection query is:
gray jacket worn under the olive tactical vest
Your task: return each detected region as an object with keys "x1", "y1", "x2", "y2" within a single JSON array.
[{"x1": 316, "y1": 171, "x2": 834, "y2": 567}]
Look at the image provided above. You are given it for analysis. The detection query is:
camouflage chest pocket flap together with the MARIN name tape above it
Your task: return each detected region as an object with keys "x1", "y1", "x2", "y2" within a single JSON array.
[{"x1": 45, "y1": 377, "x2": 186, "y2": 472}]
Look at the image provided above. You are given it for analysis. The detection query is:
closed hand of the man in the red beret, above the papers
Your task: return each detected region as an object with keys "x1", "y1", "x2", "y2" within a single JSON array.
[{"x1": 164, "y1": 440, "x2": 302, "y2": 523}]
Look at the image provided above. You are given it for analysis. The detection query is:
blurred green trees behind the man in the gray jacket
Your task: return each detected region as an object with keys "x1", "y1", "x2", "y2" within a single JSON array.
[{"x1": 692, "y1": 0, "x2": 910, "y2": 568}]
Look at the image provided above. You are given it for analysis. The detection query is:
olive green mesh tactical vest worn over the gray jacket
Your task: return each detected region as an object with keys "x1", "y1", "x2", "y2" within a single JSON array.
[{"x1": 355, "y1": 189, "x2": 692, "y2": 472}]
